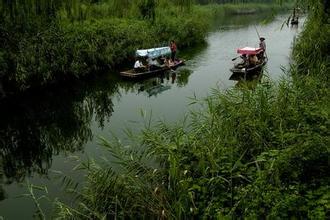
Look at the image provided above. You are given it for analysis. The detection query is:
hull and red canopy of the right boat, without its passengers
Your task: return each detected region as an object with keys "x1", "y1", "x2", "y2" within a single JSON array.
[{"x1": 229, "y1": 47, "x2": 268, "y2": 80}]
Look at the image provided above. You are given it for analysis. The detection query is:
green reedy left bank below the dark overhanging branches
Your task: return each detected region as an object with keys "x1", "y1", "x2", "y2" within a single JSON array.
[{"x1": 0, "y1": 3, "x2": 292, "y2": 94}]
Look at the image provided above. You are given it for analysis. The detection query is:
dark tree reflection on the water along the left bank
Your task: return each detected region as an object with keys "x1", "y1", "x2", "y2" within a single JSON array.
[{"x1": 0, "y1": 75, "x2": 118, "y2": 199}]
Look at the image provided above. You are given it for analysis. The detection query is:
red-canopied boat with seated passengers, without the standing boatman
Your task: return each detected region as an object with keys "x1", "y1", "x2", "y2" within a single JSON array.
[{"x1": 230, "y1": 47, "x2": 268, "y2": 79}]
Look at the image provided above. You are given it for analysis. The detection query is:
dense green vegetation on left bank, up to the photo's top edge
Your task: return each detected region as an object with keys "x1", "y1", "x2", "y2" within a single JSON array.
[{"x1": 0, "y1": 0, "x2": 288, "y2": 93}]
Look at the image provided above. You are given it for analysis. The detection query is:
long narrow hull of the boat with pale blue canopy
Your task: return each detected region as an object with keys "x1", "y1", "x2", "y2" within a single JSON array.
[{"x1": 120, "y1": 59, "x2": 185, "y2": 78}]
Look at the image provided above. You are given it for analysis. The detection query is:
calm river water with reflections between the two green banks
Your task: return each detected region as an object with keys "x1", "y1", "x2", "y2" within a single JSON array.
[{"x1": 0, "y1": 14, "x2": 303, "y2": 219}]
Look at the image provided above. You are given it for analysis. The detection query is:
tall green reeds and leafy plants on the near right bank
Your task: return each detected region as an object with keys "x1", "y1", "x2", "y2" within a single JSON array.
[{"x1": 52, "y1": 1, "x2": 330, "y2": 219}]
